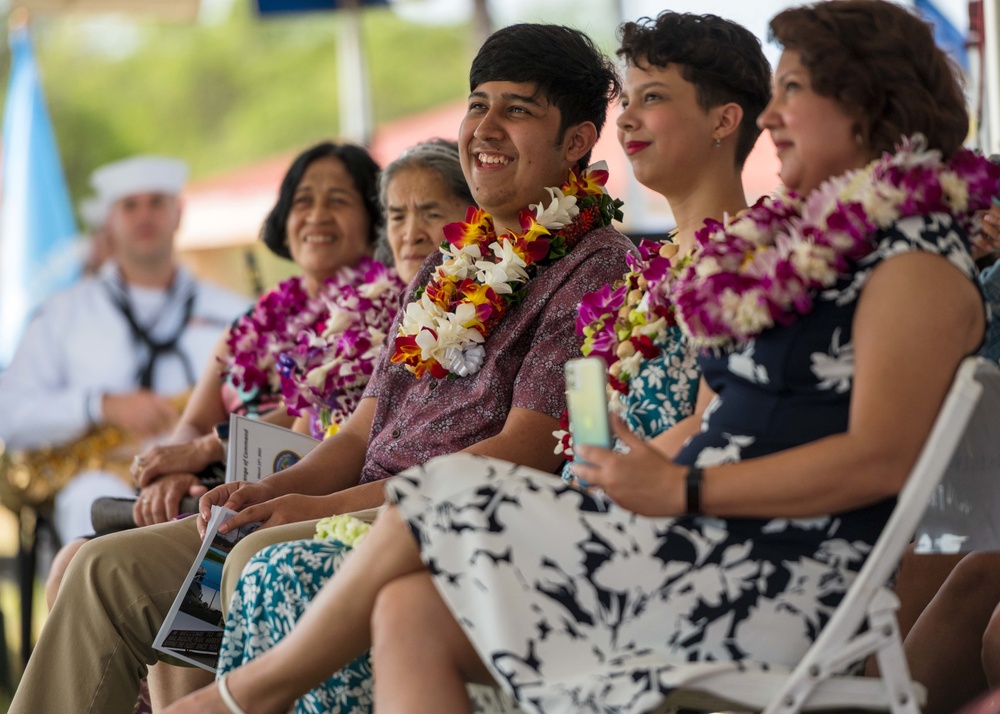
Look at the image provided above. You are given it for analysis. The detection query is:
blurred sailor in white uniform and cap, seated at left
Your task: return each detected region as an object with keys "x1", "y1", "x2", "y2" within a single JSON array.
[{"x1": 0, "y1": 156, "x2": 247, "y2": 543}]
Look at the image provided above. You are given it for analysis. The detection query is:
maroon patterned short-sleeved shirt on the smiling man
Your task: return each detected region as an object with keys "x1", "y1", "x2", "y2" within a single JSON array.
[{"x1": 361, "y1": 228, "x2": 634, "y2": 483}]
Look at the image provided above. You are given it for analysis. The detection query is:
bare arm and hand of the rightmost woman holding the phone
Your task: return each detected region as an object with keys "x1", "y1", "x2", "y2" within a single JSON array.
[{"x1": 576, "y1": 253, "x2": 984, "y2": 518}]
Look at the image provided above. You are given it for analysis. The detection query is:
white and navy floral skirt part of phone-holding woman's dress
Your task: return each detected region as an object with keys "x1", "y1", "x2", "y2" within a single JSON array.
[{"x1": 387, "y1": 454, "x2": 870, "y2": 714}]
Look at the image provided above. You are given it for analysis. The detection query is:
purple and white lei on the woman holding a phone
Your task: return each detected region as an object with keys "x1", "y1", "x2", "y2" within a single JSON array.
[{"x1": 671, "y1": 134, "x2": 1000, "y2": 348}]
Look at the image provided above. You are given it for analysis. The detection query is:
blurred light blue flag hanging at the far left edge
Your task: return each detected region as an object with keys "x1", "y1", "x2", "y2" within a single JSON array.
[{"x1": 0, "y1": 10, "x2": 81, "y2": 369}]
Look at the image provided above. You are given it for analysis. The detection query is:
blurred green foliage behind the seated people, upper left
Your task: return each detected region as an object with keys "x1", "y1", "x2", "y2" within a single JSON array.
[{"x1": 0, "y1": 1, "x2": 472, "y2": 207}]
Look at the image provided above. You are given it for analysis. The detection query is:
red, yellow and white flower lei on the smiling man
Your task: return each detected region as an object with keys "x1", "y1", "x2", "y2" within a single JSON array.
[{"x1": 391, "y1": 165, "x2": 622, "y2": 379}]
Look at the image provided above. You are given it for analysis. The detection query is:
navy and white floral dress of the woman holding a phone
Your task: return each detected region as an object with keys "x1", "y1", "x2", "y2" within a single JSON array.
[{"x1": 387, "y1": 214, "x2": 975, "y2": 714}]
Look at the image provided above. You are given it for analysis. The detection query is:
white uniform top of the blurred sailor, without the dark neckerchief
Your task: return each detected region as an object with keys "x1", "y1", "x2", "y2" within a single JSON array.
[{"x1": 0, "y1": 264, "x2": 249, "y2": 449}]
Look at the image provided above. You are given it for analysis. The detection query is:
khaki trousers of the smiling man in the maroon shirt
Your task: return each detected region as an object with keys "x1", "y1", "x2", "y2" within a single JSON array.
[{"x1": 9, "y1": 509, "x2": 377, "y2": 714}]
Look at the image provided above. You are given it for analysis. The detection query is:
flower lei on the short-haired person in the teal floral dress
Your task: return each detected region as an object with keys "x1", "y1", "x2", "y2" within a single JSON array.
[{"x1": 553, "y1": 239, "x2": 691, "y2": 461}]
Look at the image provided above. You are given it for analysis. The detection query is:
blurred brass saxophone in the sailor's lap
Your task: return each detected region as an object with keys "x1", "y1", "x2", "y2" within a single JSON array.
[{"x1": 0, "y1": 393, "x2": 190, "y2": 513}]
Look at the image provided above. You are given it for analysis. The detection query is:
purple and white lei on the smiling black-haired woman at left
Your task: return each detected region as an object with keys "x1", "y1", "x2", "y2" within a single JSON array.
[{"x1": 224, "y1": 258, "x2": 403, "y2": 427}]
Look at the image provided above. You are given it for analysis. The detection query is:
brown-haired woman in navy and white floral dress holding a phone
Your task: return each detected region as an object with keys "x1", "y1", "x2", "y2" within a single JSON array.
[{"x1": 168, "y1": 0, "x2": 1000, "y2": 713}]
